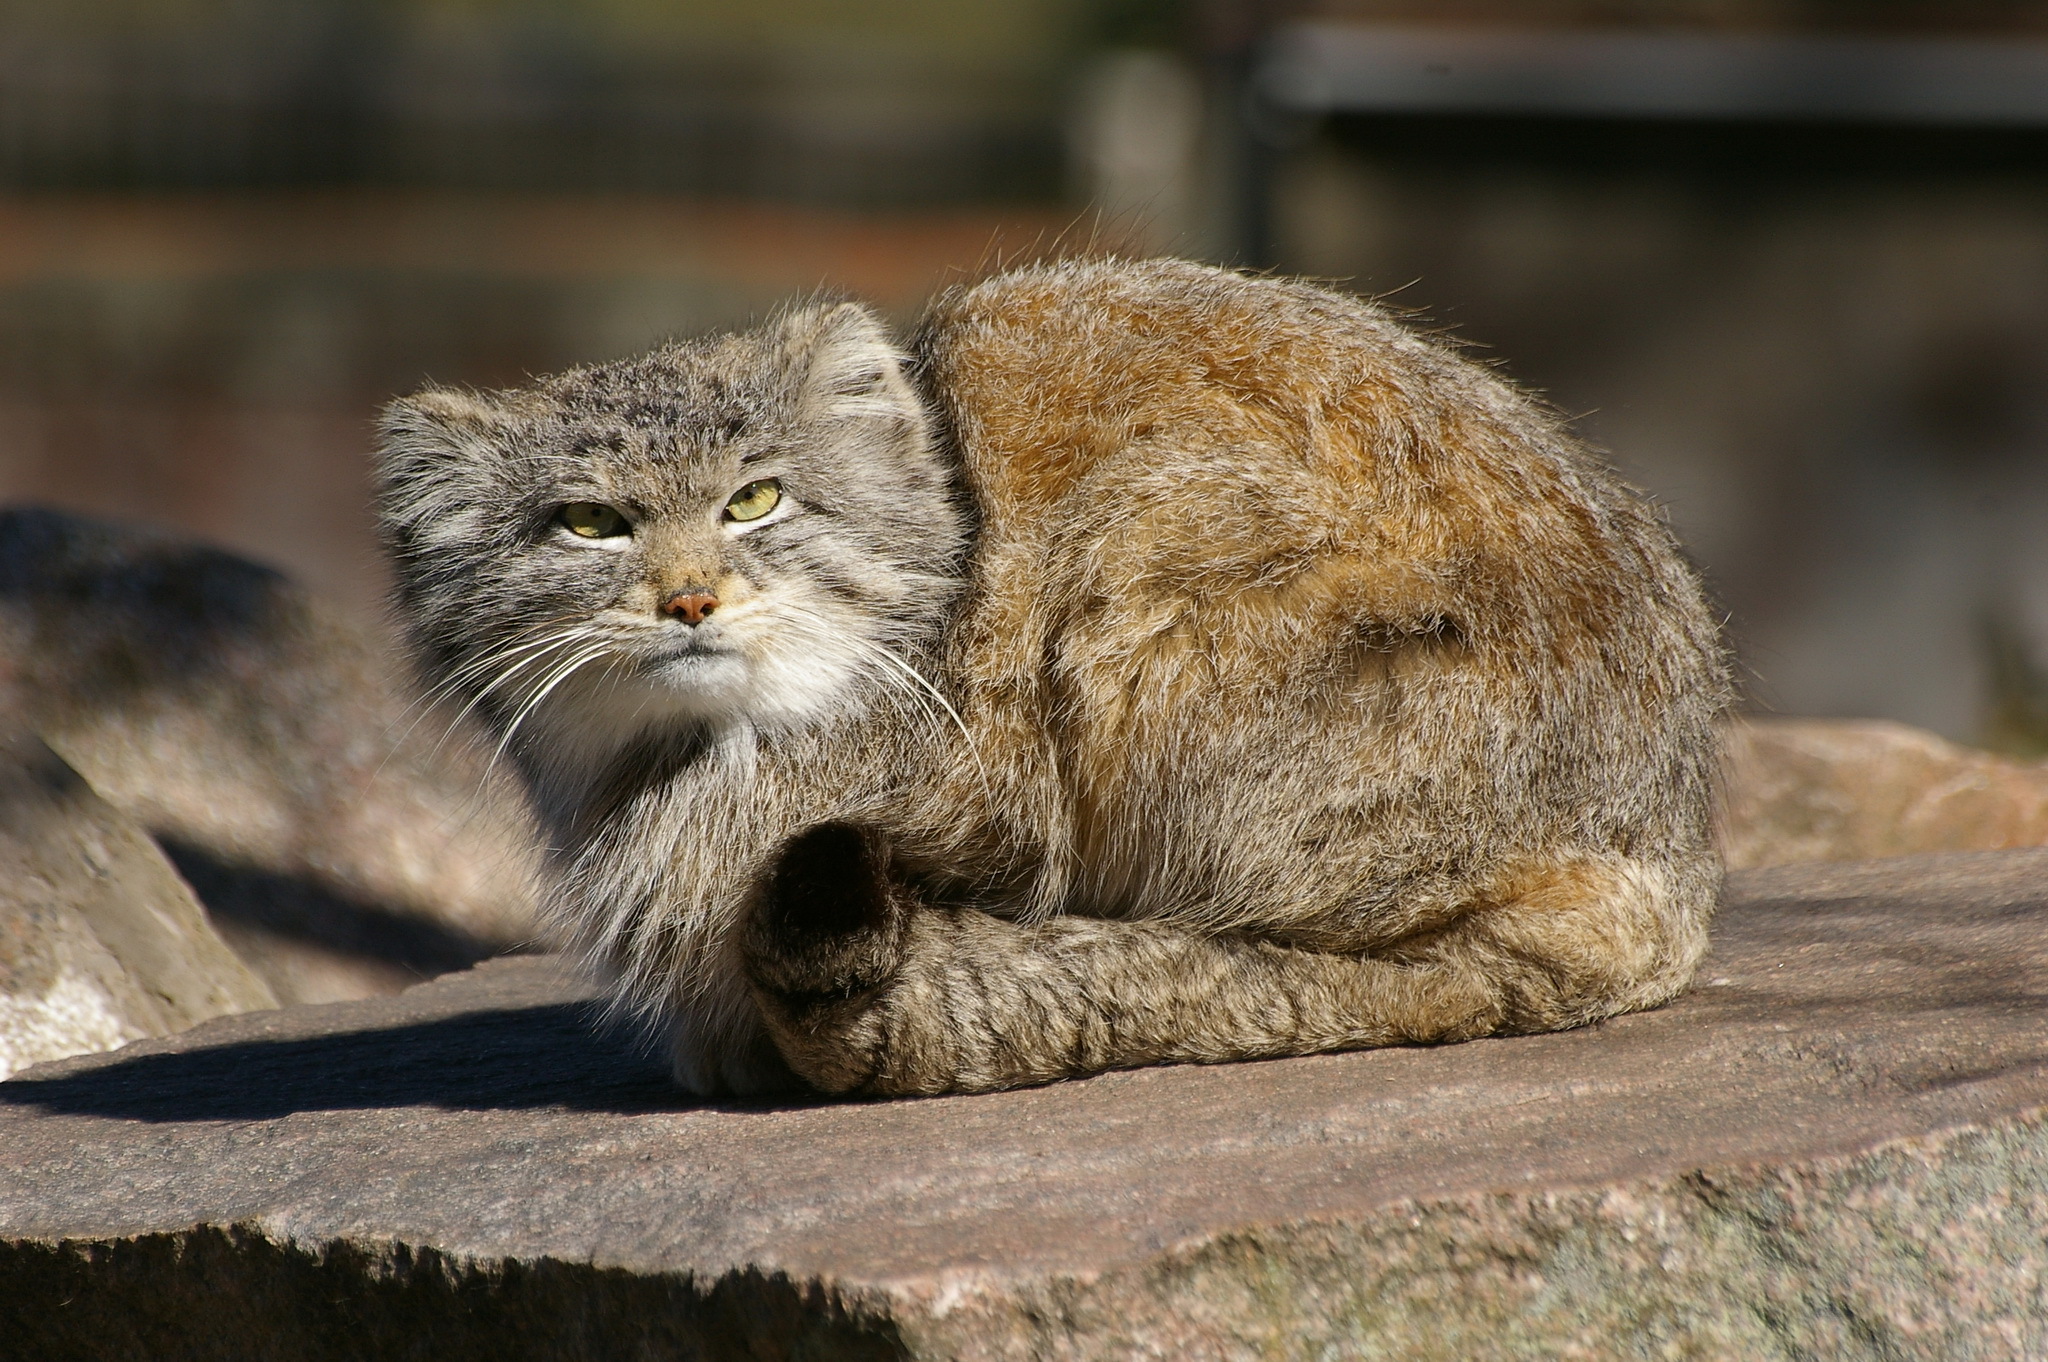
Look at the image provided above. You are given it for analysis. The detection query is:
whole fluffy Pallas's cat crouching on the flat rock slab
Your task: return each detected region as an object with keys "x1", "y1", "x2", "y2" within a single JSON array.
[{"x1": 381, "y1": 260, "x2": 1729, "y2": 1094}]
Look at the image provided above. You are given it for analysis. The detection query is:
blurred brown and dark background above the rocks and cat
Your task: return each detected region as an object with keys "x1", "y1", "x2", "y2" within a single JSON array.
[{"x1": 0, "y1": 0, "x2": 2048, "y2": 754}]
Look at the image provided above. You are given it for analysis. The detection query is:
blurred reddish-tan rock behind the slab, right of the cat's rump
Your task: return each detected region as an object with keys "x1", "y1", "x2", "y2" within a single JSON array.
[{"x1": 1722, "y1": 719, "x2": 2048, "y2": 868}]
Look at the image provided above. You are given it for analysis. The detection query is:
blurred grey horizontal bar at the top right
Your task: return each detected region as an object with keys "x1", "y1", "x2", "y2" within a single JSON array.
[{"x1": 1251, "y1": 23, "x2": 2048, "y2": 127}]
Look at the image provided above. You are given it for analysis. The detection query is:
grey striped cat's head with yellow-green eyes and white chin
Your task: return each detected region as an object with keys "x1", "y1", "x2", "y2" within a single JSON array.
[{"x1": 379, "y1": 303, "x2": 967, "y2": 786}]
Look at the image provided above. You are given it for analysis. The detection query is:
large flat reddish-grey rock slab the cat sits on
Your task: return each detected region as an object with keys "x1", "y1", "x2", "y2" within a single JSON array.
[{"x1": 0, "y1": 852, "x2": 2048, "y2": 1362}]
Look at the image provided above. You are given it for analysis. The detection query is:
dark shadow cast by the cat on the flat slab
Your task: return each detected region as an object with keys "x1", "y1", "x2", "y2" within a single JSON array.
[{"x1": 0, "y1": 1002, "x2": 827, "y2": 1122}]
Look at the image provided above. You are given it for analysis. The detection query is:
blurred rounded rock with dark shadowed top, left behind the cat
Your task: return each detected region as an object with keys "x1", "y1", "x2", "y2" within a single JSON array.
[{"x1": 0, "y1": 508, "x2": 532, "y2": 1002}]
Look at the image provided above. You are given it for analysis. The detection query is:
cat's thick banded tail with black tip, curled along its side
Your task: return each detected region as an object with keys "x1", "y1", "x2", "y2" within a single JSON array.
[{"x1": 741, "y1": 825, "x2": 1704, "y2": 1094}]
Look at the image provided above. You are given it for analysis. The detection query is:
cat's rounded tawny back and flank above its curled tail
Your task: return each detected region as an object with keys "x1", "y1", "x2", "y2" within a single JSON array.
[{"x1": 915, "y1": 260, "x2": 1726, "y2": 922}]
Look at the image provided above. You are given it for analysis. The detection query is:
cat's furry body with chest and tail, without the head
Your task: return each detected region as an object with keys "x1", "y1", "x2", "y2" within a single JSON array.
[{"x1": 380, "y1": 260, "x2": 1726, "y2": 1094}]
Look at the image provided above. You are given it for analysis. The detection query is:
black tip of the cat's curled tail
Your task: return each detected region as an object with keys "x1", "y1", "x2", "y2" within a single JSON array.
[{"x1": 743, "y1": 823, "x2": 905, "y2": 1014}]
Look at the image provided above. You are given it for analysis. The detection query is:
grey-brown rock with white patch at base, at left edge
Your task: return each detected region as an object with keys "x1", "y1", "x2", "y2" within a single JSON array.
[{"x1": 0, "y1": 727, "x2": 276, "y2": 1077}]
